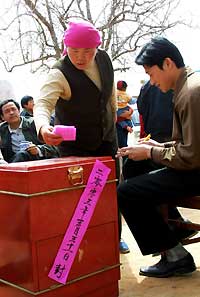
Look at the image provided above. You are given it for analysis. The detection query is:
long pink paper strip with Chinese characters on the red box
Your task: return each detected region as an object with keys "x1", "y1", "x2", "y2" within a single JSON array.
[{"x1": 48, "y1": 160, "x2": 111, "y2": 284}]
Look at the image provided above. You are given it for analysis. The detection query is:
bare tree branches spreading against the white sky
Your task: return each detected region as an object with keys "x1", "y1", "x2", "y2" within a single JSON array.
[{"x1": 0, "y1": 0, "x2": 188, "y2": 71}]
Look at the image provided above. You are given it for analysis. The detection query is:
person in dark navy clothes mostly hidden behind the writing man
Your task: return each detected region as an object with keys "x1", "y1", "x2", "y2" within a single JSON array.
[{"x1": 136, "y1": 81, "x2": 197, "y2": 241}]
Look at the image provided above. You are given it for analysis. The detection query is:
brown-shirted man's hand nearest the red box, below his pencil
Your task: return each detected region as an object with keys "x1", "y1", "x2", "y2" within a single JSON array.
[{"x1": 116, "y1": 144, "x2": 152, "y2": 161}]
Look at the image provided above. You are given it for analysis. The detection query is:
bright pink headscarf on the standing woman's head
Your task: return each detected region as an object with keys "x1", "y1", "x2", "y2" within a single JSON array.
[{"x1": 63, "y1": 21, "x2": 101, "y2": 54}]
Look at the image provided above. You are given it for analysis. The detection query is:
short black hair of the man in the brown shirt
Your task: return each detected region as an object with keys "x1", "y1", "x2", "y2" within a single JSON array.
[{"x1": 135, "y1": 36, "x2": 185, "y2": 69}]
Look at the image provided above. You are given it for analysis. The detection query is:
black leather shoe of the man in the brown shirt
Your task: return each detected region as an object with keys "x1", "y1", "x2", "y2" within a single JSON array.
[{"x1": 140, "y1": 253, "x2": 196, "y2": 277}]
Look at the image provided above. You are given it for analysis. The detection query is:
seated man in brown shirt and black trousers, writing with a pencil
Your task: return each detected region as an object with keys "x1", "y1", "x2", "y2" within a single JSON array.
[{"x1": 117, "y1": 37, "x2": 200, "y2": 277}]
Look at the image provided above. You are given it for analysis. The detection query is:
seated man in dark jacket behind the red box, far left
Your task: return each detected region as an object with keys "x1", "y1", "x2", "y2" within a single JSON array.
[{"x1": 0, "y1": 99, "x2": 59, "y2": 163}]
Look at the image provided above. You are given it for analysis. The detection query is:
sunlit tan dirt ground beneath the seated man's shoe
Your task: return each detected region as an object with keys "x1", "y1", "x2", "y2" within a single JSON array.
[{"x1": 119, "y1": 209, "x2": 200, "y2": 297}]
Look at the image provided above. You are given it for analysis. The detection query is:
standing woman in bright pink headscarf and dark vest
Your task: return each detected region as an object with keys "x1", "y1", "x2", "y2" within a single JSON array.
[{"x1": 34, "y1": 22, "x2": 129, "y2": 253}]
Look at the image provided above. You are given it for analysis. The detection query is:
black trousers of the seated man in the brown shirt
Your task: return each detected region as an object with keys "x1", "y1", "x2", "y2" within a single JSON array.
[{"x1": 117, "y1": 160, "x2": 200, "y2": 255}]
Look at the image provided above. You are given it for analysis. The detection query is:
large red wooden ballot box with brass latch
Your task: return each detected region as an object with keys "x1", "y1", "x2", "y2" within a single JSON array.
[{"x1": 0, "y1": 157, "x2": 120, "y2": 297}]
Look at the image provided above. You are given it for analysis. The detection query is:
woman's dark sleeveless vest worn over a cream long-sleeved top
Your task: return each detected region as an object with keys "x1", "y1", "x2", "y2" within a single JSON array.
[{"x1": 53, "y1": 50, "x2": 114, "y2": 155}]
